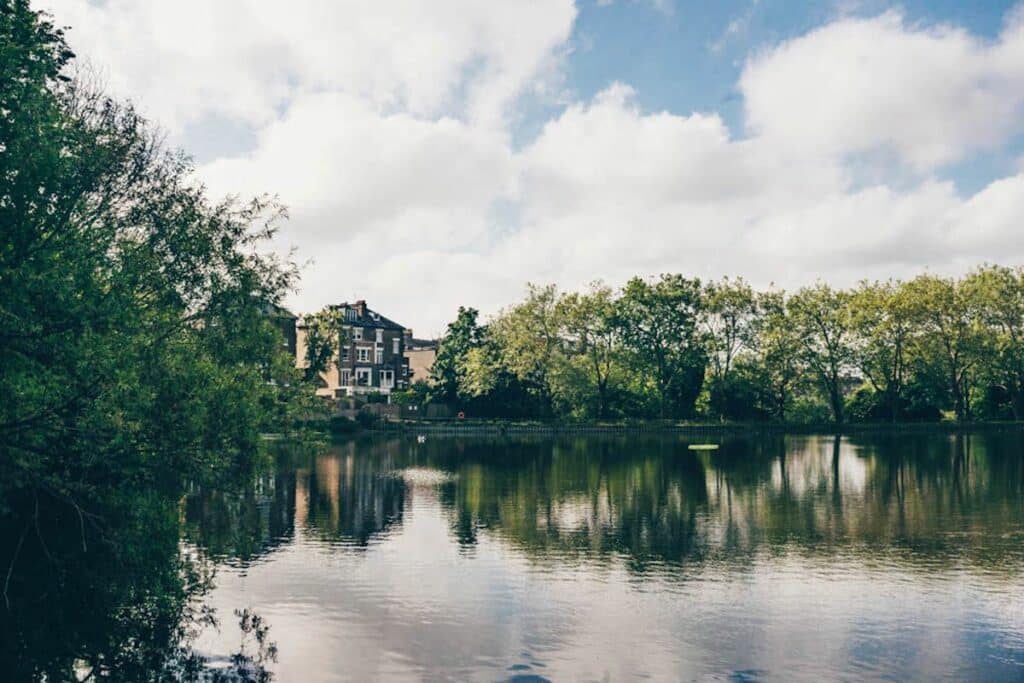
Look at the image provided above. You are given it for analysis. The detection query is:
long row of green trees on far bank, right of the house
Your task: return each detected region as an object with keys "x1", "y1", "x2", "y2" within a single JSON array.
[{"x1": 406, "y1": 265, "x2": 1024, "y2": 423}]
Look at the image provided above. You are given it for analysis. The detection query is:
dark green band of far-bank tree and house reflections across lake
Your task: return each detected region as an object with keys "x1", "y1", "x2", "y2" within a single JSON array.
[{"x1": 186, "y1": 434, "x2": 1024, "y2": 573}]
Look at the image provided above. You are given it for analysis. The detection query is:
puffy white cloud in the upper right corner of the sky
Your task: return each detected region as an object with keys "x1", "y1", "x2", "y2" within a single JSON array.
[{"x1": 739, "y1": 11, "x2": 1024, "y2": 171}]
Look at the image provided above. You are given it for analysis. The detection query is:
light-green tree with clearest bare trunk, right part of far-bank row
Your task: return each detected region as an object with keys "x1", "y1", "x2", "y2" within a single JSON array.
[{"x1": 786, "y1": 283, "x2": 854, "y2": 424}]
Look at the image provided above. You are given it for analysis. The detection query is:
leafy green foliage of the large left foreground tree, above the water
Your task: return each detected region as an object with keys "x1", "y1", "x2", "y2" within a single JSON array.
[{"x1": 0, "y1": 1, "x2": 302, "y2": 501}]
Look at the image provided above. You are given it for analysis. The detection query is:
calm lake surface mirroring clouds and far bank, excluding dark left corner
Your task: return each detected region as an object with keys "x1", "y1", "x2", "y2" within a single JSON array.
[{"x1": 185, "y1": 435, "x2": 1024, "y2": 681}]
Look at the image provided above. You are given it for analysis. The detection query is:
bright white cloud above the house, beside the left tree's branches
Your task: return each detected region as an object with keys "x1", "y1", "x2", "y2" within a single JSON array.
[{"x1": 203, "y1": 94, "x2": 512, "y2": 242}]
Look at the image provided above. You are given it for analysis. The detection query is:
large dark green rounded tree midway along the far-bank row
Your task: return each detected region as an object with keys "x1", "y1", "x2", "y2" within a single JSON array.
[{"x1": 615, "y1": 274, "x2": 707, "y2": 418}]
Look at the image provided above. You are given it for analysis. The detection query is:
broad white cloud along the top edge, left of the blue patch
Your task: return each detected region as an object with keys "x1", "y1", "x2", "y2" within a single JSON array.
[{"x1": 40, "y1": 0, "x2": 575, "y2": 131}]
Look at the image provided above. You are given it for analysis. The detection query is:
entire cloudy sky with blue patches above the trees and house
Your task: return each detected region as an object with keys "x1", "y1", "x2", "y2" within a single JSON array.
[{"x1": 38, "y1": 0, "x2": 1024, "y2": 335}]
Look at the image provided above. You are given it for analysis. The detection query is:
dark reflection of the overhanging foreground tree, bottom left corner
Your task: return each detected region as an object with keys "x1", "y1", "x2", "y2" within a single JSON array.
[{"x1": 0, "y1": 483, "x2": 275, "y2": 681}]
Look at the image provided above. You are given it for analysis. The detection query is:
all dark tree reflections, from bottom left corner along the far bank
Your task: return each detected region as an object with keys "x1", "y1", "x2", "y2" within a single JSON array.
[{"x1": 14, "y1": 434, "x2": 1024, "y2": 681}]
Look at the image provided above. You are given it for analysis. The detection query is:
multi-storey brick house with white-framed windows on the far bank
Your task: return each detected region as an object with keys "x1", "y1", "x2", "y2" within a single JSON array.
[{"x1": 296, "y1": 300, "x2": 412, "y2": 397}]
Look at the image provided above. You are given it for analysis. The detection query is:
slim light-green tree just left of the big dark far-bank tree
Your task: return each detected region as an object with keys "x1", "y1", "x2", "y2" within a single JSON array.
[{"x1": 556, "y1": 283, "x2": 621, "y2": 418}]
